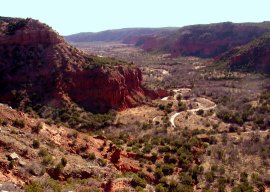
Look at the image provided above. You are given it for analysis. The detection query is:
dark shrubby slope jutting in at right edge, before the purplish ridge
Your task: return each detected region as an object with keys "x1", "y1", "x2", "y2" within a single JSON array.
[{"x1": 217, "y1": 33, "x2": 270, "y2": 74}]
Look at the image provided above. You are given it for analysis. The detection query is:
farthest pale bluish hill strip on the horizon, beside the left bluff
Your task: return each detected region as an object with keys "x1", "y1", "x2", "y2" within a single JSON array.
[{"x1": 65, "y1": 28, "x2": 177, "y2": 43}]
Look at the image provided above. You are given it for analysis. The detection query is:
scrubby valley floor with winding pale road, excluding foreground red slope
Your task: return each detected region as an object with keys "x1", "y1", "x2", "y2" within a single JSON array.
[{"x1": 75, "y1": 43, "x2": 270, "y2": 191}]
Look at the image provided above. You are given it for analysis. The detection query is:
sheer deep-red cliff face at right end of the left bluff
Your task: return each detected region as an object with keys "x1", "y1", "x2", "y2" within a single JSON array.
[{"x1": 66, "y1": 66, "x2": 144, "y2": 112}]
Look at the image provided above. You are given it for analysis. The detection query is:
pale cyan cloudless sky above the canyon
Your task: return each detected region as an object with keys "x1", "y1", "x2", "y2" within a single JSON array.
[{"x1": 0, "y1": 0, "x2": 270, "y2": 35}]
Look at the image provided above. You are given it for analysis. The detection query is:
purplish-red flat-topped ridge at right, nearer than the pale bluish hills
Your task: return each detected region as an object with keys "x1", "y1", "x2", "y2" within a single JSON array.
[{"x1": 135, "y1": 22, "x2": 270, "y2": 58}]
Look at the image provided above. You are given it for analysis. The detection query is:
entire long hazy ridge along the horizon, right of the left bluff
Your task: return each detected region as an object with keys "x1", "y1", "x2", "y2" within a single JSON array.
[{"x1": 65, "y1": 22, "x2": 270, "y2": 58}]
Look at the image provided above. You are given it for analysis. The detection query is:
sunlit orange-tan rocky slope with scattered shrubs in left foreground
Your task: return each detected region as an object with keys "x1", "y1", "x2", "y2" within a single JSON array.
[{"x1": 0, "y1": 104, "x2": 141, "y2": 192}]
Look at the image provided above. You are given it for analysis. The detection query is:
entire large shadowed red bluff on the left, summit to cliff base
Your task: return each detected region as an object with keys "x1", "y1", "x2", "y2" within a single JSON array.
[{"x1": 0, "y1": 17, "x2": 156, "y2": 112}]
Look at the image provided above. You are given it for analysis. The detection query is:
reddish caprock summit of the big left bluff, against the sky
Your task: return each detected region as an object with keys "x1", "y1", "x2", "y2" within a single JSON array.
[{"x1": 0, "y1": 18, "x2": 64, "y2": 45}]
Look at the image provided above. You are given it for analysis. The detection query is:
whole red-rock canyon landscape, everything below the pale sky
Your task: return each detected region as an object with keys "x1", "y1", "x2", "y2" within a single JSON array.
[{"x1": 0, "y1": 17, "x2": 270, "y2": 192}]
